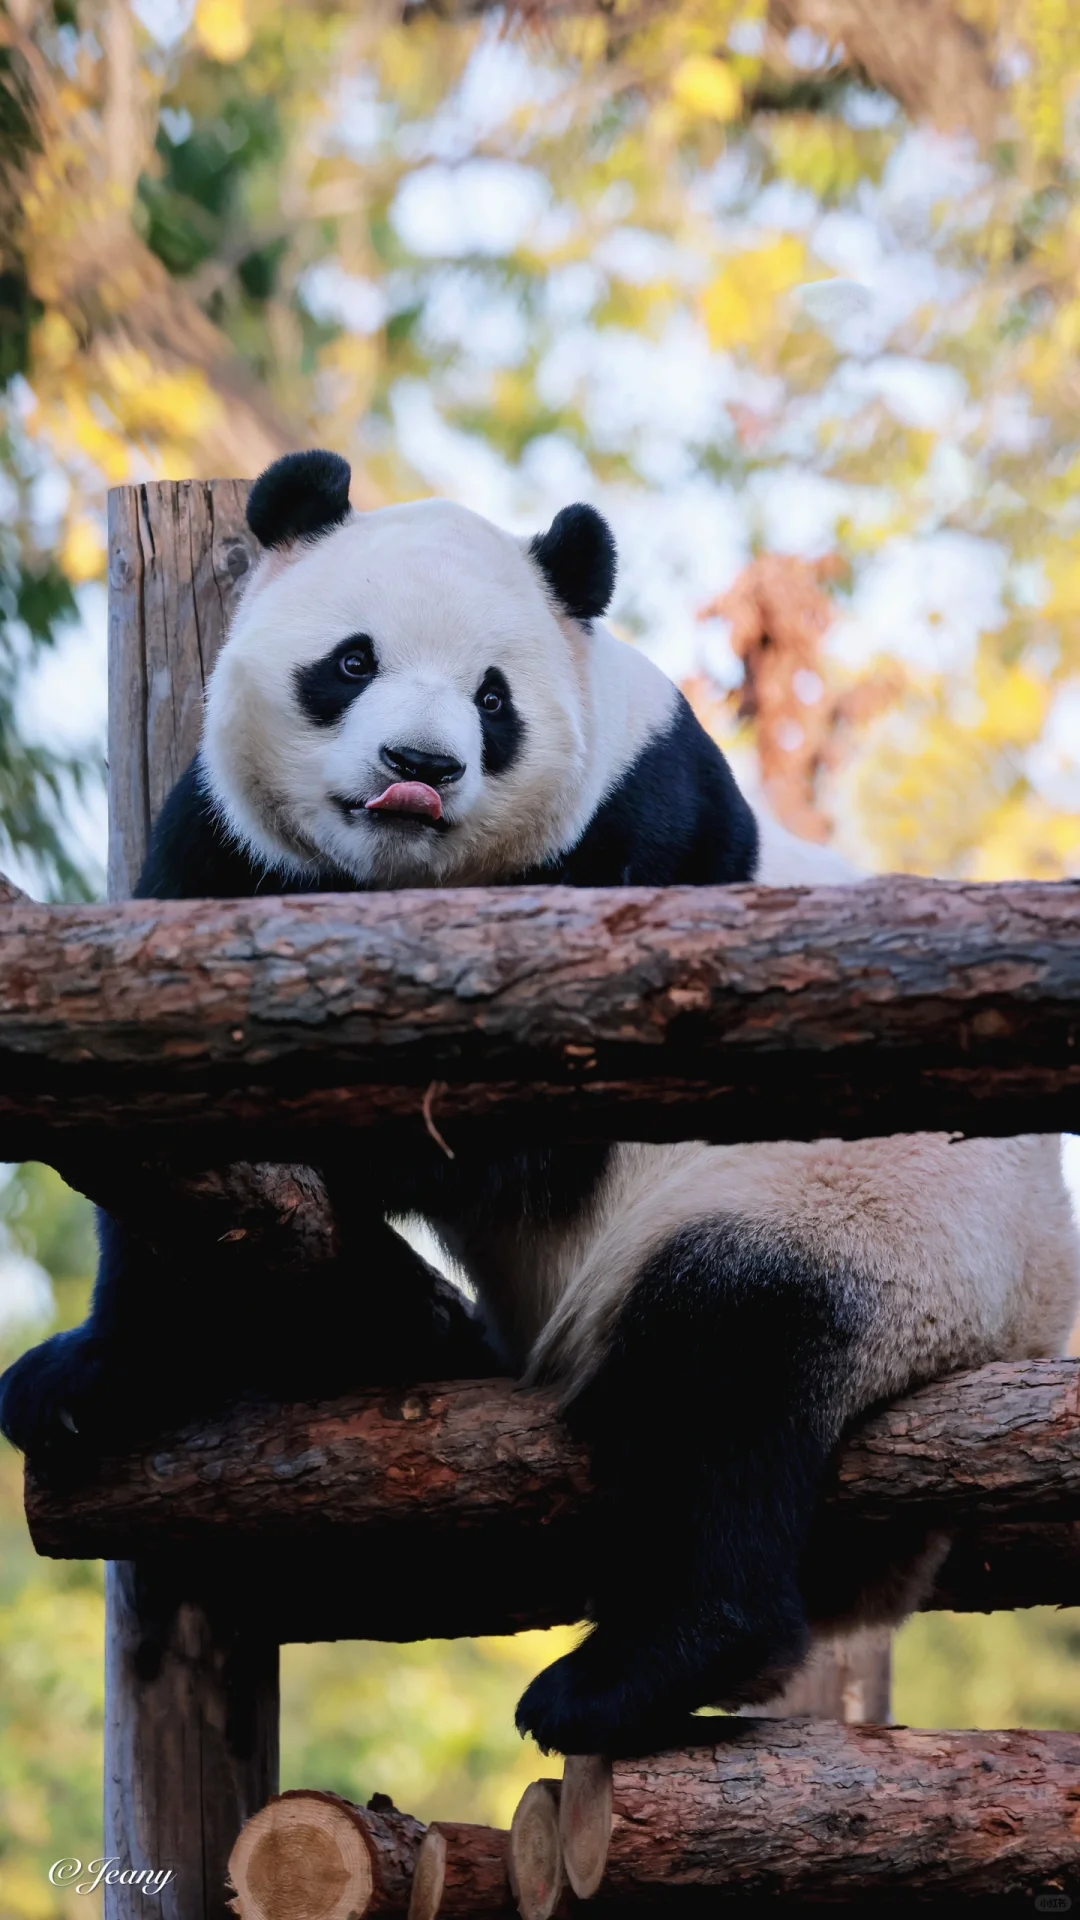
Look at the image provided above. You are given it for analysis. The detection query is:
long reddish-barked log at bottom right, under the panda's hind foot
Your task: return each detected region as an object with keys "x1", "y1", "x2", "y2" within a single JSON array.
[{"x1": 563, "y1": 1718, "x2": 1080, "y2": 1910}]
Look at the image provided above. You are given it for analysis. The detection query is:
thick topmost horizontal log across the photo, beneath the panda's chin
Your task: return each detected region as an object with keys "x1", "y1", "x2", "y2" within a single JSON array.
[{"x1": 0, "y1": 879, "x2": 1080, "y2": 1160}]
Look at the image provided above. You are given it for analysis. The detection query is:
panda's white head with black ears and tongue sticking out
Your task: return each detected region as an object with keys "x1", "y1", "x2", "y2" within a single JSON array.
[{"x1": 202, "y1": 453, "x2": 615, "y2": 887}]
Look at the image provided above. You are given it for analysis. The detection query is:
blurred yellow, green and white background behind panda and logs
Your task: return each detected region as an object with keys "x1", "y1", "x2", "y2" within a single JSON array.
[{"x1": 0, "y1": 0, "x2": 1080, "y2": 1920}]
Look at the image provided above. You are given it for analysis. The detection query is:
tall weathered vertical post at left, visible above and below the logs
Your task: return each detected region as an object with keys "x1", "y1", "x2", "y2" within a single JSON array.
[{"x1": 106, "y1": 480, "x2": 279, "y2": 1920}]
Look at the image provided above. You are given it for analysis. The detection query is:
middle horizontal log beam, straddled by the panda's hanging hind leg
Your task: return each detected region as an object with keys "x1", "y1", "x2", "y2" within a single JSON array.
[{"x1": 27, "y1": 1361, "x2": 1080, "y2": 1640}]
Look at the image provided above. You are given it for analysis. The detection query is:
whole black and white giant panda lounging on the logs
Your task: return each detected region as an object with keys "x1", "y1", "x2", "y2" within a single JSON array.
[{"x1": 0, "y1": 453, "x2": 1080, "y2": 1753}]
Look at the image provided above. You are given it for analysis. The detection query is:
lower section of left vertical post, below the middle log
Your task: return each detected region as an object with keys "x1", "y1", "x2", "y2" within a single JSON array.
[{"x1": 104, "y1": 1565, "x2": 279, "y2": 1920}]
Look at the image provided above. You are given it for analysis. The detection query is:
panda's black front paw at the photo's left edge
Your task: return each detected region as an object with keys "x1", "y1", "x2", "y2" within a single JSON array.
[{"x1": 0, "y1": 1327, "x2": 115, "y2": 1461}]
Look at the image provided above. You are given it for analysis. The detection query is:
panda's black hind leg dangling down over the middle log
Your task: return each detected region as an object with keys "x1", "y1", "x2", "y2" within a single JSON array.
[{"x1": 517, "y1": 1223, "x2": 857, "y2": 1753}]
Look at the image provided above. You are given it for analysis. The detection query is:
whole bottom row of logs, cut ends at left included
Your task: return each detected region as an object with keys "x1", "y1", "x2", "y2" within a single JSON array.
[{"x1": 231, "y1": 1718, "x2": 1080, "y2": 1920}]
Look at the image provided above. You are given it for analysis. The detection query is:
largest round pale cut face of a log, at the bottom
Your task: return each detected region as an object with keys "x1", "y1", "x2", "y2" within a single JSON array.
[{"x1": 229, "y1": 1793, "x2": 375, "y2": 1920}]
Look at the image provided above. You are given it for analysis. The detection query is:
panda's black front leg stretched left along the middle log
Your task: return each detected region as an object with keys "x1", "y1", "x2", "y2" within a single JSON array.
[{"x1": 0, "y1": 1204, "x2": 496, "y2": 1467}]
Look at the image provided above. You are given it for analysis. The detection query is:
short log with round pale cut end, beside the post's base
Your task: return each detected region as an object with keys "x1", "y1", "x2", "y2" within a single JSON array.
[{"x1": 229, "y1": 1789, "x2": 425, "y2": 1920}]
